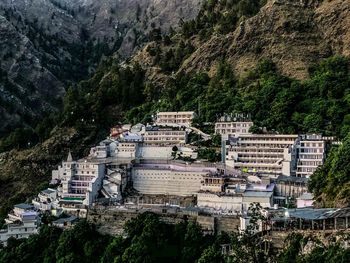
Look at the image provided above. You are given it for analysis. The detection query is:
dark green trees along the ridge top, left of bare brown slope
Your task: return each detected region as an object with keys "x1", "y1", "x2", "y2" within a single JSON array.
[{"x1": 147, "y1": 0, "x2": 266, "y2": 74}]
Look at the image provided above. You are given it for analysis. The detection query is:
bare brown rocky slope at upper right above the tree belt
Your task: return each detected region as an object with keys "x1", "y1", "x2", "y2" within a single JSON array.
[{"x1": 172, "y1": 0, "x2": 350, "y2": 79}]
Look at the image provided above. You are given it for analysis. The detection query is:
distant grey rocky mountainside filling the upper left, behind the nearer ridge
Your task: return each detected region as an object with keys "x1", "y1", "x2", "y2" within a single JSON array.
[{"x1": 0, "y1": 0, "x2": 201, "y2": 136}]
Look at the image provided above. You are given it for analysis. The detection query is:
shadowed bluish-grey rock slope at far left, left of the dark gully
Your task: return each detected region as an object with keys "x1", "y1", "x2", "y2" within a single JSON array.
[{"x1": 0, "y1": 16, "x2": 64, "y2": 134}]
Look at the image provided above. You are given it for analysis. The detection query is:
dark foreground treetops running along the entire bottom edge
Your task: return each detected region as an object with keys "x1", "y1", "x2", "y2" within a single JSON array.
[{"x1": 0, "y1": 207, "x2": 350, "y2": 263}]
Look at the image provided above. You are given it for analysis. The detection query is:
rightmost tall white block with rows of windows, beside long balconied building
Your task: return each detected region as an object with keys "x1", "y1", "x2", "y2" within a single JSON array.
[{"x1": 296, "y1": 134, "x2": 326, "y2": 178}]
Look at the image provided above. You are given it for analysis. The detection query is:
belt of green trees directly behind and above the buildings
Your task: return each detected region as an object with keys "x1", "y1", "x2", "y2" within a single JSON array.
[{"x1": 0, "y1": 56, "x2": 350, "y2": 208}]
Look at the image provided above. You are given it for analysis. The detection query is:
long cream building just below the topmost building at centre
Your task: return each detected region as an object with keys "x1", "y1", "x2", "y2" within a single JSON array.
[{"x1": 143, "y1": 126, "x2": 187, "y2": 145}]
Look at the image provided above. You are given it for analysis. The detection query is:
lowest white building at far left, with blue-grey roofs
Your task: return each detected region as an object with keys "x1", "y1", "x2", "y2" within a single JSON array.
[{"x1": 0, "y1": 204, "x2": 39, "y2": 246}]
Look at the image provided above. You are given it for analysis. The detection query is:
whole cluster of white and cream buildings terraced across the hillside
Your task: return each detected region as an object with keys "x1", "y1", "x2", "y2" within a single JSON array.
[{"x1": 0, "y1": 112, "x2": 336, "y2": 244}]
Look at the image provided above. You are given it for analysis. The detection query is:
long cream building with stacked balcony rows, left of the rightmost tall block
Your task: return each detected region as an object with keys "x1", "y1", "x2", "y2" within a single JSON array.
[{"x1": 222, "y1": 134, "x2": 298, "y2": 176}]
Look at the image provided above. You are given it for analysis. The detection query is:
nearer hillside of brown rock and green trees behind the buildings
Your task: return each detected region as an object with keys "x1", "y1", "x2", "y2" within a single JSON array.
[{"x1": 0, "y1": 0, "x2": 350, "y2": 227}]
